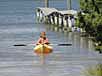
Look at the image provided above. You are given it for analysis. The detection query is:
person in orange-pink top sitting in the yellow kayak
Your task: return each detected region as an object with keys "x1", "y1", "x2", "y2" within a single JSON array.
[{"x1": 36, "y1": 32, "x2": 49, "y2": 45}]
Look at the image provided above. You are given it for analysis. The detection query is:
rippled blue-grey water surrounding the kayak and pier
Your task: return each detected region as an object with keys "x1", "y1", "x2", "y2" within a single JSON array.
[{"x1": 0, "y1": 0, "x2": 102, "y2": 76}]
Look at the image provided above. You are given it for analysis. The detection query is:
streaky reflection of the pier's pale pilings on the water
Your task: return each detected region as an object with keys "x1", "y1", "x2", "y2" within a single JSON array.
[{"x1": 46, "y1": 24, "x2": 94, "y2": 51}]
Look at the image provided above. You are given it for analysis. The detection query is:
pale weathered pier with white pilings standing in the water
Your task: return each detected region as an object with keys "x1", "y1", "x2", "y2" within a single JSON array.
[{"x1": 36, "y1": 7, "x2": 77, "y2": 31}]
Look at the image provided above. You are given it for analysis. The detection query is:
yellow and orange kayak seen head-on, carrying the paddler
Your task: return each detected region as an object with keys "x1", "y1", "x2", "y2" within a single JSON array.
[{"x1": 34, "y1": 44, "x2": 53, "y2": 54}]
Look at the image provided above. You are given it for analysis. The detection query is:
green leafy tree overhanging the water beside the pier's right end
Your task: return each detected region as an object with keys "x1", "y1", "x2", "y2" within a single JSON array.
[{"x1": 78, "y1": 0, "x2": 102, "y2": 44}]
